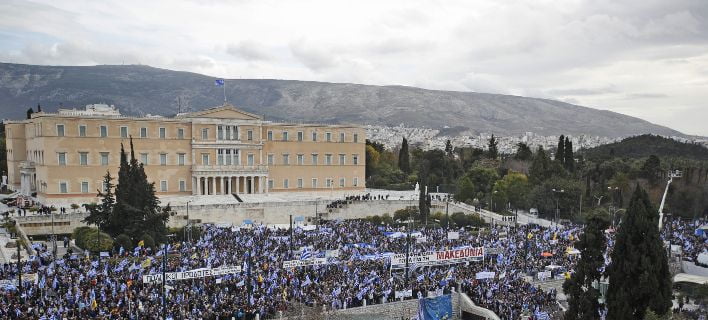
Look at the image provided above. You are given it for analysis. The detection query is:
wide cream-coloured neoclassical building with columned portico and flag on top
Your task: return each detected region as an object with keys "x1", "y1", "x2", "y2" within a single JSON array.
[{"x1": 5, "y1": 104, "x2": 366, "y2": 202}]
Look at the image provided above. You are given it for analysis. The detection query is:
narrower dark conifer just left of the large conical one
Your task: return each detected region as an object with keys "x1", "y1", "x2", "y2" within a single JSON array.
[{"x1": 563, "y1": 213, "x2": 610, "y2": 320}]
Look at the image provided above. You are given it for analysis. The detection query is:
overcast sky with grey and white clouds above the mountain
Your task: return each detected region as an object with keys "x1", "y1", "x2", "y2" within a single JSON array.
[{"x1": 0, "y1": 0, "x2": 708, "y2": 136}]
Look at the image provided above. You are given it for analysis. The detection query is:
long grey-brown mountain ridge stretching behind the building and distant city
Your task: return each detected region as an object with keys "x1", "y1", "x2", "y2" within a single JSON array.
[{"x1": 0, "y1": 63, "x2": 683, "y2": 137}]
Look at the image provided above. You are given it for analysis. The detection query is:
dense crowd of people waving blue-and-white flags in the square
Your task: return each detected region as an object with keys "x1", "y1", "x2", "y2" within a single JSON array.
[{"x1": 0, "y1": 214, "x2": 705, "y2": 319}]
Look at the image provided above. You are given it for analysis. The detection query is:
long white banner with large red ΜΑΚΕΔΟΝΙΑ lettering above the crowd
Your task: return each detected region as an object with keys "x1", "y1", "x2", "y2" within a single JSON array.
[{"x1": 391, "y1": 247, "x2": 484, "y2": 267}]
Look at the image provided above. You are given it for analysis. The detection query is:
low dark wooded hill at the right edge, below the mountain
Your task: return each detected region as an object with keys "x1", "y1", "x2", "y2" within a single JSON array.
[{"x1": 581, "y1": 134, "x2": 708, "y2": 160}]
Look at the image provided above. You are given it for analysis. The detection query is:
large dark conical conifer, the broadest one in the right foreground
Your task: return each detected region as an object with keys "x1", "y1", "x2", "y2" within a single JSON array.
[{"x1": 606, "y1": 185, "x2": 671, "y2": 320}]
